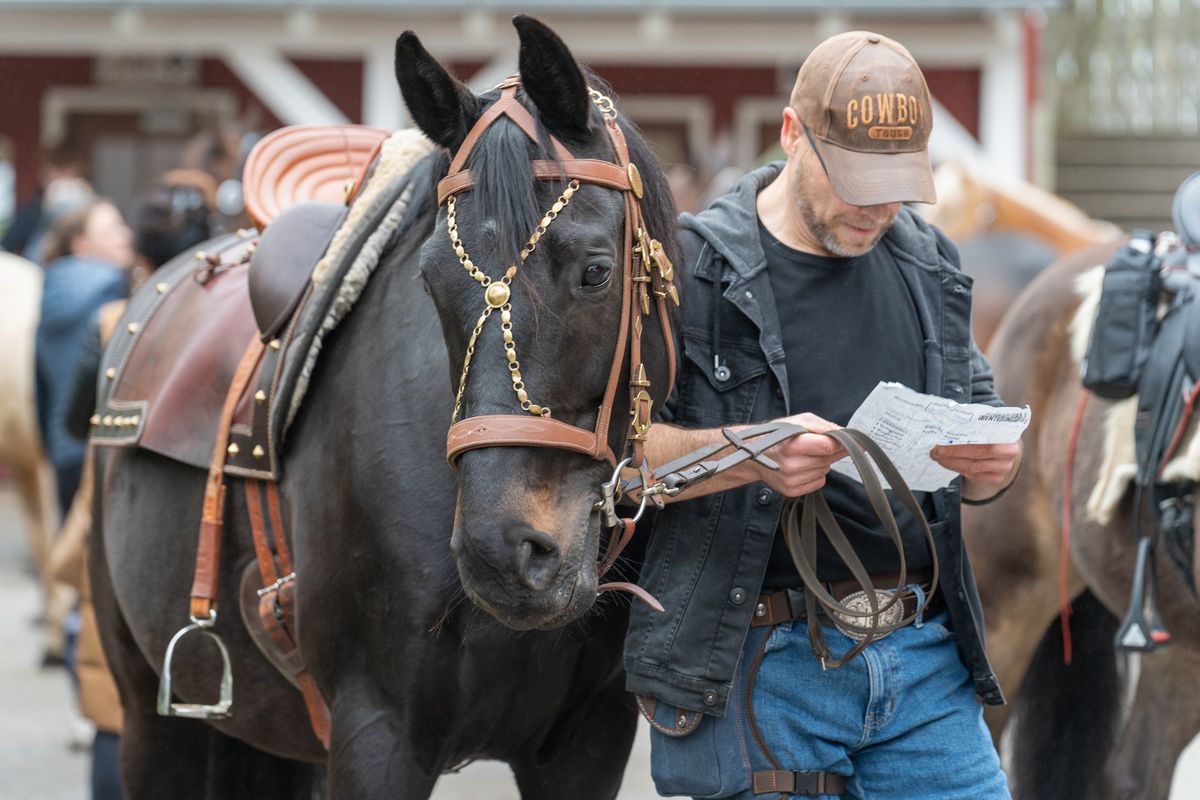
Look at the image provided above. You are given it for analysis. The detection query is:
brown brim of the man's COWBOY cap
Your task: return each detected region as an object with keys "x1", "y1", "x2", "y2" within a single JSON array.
[{"x1": 814, "y1": 139, "x2": 937, "y2": 205}]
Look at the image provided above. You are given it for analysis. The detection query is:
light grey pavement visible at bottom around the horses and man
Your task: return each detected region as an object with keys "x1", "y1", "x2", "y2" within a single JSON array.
[{"x1": 0, "y1": 481, "x2": 1200, "y2": 800}]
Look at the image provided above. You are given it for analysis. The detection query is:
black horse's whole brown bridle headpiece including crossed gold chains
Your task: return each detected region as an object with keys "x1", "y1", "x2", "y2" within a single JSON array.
[{"x1": 438, "y1": 78, "x2": 679, "y2": 465}]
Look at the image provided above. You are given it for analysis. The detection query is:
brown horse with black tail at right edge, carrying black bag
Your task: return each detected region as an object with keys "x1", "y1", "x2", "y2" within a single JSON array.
[{"x1": 964, "y1": 245, "x2": 1200, "y2": 800}]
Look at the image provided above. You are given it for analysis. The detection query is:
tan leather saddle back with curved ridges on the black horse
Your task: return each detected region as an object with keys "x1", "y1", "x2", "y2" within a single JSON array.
[{"x1": 241, "y1": 125, "x2": 391, "y2": 230}]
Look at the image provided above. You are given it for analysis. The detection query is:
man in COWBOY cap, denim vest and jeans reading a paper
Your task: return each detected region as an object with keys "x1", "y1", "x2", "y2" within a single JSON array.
[{"x1": 625, "y1": 31, "x2": 1020, "y2": 800}]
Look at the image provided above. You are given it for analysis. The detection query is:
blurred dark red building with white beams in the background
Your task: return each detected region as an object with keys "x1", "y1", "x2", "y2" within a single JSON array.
[{"x1": 0, "y1": 0, "x2": 1060, "y2": 217}]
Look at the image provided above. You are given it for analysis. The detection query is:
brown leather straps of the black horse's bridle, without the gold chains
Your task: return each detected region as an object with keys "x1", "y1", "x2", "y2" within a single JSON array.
[{"x1": 438, "y1": 79, "x2": 678, "y2": 465}]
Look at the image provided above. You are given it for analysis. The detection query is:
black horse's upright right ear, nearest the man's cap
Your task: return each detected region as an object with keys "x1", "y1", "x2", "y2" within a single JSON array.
[{"x1": 512, "y1": 14, "x2": 590, "y2": 137}]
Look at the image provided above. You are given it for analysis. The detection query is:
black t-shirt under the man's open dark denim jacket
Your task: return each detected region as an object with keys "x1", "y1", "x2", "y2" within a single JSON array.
[{"x1": 758, "y1": 224, "x2": 932, "y2": 590}]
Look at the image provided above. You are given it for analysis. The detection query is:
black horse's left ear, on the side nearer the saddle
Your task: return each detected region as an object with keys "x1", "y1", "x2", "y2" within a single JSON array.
[{"x1": 396, "y1": 30, "x2": 479, "y2": 151}]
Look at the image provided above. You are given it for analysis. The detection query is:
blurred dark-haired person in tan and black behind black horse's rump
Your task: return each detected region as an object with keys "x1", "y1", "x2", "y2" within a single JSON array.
[{"x1": 47, "y1": 175, "x2": 216, "y2": 800}]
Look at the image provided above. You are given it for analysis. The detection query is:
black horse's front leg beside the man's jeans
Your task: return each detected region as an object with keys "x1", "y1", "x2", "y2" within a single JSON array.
[{"x1": 512, "y1": 681, "x2": 637, "y2": 800}]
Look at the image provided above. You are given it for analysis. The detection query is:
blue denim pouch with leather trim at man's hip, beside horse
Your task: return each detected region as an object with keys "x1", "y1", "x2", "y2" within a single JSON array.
[{"x1": 637, "y1": 697, "x2": 750, "y2": 799}]
